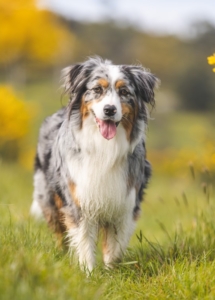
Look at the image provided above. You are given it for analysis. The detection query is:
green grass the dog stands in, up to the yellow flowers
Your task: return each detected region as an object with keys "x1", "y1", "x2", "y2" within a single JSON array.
[{"x1": 0, "y1": 164, "x2": 215, "y2": 299}]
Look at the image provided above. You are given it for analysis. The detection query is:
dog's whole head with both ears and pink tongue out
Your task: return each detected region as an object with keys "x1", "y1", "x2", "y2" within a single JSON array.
[{"x1": 63, "y1": 57, "x2": 158, "y2": 141}]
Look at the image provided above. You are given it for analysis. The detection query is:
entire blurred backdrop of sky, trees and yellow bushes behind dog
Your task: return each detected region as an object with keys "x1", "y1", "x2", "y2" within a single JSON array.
[{"x1": 0, "y1": 0, "x2": 215, "y2": 239}]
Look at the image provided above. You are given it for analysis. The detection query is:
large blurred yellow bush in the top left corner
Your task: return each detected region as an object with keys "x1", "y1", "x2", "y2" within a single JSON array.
[{"x1": 0, "y1": 0, "x2": 76, "y2": 66}]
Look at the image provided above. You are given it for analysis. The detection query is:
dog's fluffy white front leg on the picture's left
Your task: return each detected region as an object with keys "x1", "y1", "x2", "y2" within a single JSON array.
[{"x1": 68, "y1": 219, "x2": 98, "y2": 272}]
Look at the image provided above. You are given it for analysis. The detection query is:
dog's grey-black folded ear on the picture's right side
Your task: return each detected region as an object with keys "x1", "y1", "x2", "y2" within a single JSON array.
[{"x1": 124, "y1": 66, "x2": 160, "y2": 106}]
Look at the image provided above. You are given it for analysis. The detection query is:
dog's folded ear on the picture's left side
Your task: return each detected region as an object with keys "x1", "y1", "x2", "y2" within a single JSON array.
[{"x1": 61, "y1": 64, "x2": 83, "y2": 94}]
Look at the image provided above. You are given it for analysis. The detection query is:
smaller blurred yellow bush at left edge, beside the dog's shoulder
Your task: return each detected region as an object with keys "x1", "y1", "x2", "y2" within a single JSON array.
[{"x1": 0, "y1": 85, "x2": 30, "y2": 158}]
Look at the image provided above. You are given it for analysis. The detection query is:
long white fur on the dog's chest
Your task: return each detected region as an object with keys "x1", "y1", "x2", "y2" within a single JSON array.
[{"x1": 67, "y1": 122, "x2": 134, "y2": 222}]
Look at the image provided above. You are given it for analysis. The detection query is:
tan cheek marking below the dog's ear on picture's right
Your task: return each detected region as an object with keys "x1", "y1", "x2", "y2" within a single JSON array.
[{"x1": 121, "y1": 103, "x2": 135, "y2": 141}]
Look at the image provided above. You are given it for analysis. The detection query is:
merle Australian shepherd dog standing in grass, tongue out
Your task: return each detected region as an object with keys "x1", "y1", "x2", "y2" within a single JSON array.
[{"x1": 31, "y1": 57, "x2": 158, "y2": 272}]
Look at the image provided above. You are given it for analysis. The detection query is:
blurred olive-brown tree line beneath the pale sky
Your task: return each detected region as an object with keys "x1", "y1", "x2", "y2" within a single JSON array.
[{"x1": 67, "y1": 21, "x2": 215, "y2": 111}]
